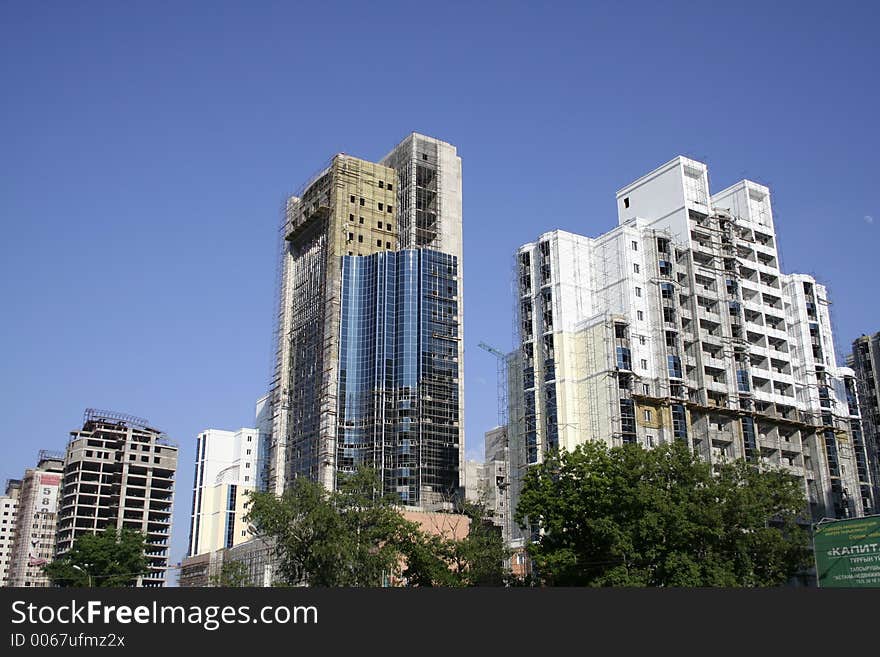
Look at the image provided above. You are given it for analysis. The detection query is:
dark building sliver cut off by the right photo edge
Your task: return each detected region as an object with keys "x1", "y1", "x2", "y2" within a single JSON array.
[{"x1": 847, "y1": 332, "x2": 880, "y2": 508}]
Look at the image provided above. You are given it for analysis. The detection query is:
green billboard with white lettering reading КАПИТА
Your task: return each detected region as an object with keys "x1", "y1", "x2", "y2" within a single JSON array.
[{"x1": 813, "y1": 516, "x2": 880, "y2": 588}]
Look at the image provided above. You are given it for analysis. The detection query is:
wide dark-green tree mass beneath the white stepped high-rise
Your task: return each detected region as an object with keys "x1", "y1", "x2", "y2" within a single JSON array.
[{"x1": 516, "y1": 442, "x2": 809, "y2": 587}]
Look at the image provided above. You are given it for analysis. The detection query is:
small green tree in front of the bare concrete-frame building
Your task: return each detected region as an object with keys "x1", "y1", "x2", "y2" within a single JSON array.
[{"x1": 43, "y1": 527, "x2": 147, "y2": 587}]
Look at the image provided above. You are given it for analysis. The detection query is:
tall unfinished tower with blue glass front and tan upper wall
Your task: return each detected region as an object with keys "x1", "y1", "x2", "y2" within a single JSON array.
[{"x1": 265, "y1": 134, "x2": 464, "y2": 505}]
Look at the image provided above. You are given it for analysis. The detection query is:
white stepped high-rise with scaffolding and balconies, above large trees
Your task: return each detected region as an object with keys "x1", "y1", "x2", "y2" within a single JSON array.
[{"x1": 510, "y1": 157, "x2": 876, "y2": 517}]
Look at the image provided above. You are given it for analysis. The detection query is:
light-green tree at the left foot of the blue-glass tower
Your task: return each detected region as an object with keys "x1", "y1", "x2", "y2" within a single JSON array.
[{"x1": 247, "y1": 469, "x2": 418, "y2": 586}]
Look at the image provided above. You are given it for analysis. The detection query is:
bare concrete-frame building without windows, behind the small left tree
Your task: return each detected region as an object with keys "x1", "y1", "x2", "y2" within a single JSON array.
[{"x1": 55, "y1": 408, "x2": 178, "y2": 587}]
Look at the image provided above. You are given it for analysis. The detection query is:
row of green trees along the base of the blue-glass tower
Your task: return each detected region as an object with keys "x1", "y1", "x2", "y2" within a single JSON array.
[{"x1": 247, "y1": 469, "x2": 506, "y2": 586}]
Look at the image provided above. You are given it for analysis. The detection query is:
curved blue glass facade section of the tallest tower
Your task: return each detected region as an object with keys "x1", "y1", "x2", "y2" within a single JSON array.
[{"x1": 336, "y1": 249, "x2": 461, "y2": 506}]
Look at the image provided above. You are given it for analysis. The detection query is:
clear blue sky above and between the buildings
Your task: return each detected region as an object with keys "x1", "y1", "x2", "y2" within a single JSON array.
[{"x1": 0, "y1": 1, "x2": 880, "y2": 580}]
